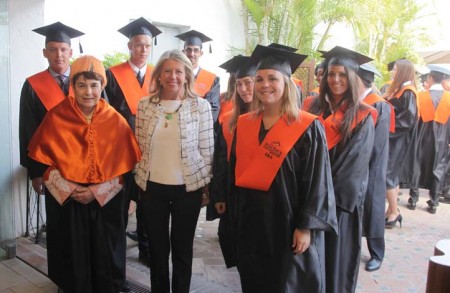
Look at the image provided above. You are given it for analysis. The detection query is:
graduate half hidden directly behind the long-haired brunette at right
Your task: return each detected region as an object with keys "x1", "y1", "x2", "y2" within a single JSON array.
[{"x1": 358, "y1": 63, "x2": 395, "y2": 272}]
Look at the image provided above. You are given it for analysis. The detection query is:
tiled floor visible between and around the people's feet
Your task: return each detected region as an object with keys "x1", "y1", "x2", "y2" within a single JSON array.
[{"x1": 5, "y1": 190, "x2": 450, "y2": 293}]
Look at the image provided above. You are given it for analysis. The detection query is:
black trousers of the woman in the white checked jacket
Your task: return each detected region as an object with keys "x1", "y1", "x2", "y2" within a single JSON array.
[{"x1": 141, "y1": 181, "x2": 202, "y2": 293}]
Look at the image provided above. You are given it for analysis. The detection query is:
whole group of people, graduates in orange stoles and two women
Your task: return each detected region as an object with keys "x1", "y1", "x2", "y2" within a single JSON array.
[{"x1": 19, "y1": 18, "x2": 450, "y2": 293}]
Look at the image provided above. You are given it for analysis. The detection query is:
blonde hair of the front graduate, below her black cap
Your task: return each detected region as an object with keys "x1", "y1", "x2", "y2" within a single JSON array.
[{"x1": 251, "y1": 74, "x2": 300, "y2": 123}]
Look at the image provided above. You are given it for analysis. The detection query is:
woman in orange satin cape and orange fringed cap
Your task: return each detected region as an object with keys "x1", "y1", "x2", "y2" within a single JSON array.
[{"x1": 29, "y1": 56, "x2": 140, "y2": 293}]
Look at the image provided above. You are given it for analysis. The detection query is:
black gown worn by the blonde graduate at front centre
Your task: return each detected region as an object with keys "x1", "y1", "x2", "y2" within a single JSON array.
[{"x1": 227, "y1": 120, "x2": 337, "y2": 293}]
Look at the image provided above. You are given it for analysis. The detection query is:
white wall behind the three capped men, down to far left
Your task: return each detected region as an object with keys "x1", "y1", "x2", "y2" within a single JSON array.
[{"x1": 8, "y1": 0, "x2": 244, "y2": 235}]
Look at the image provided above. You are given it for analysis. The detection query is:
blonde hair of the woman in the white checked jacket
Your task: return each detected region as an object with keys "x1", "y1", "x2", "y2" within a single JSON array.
[{"x1": 149, "y1": 50, "x2": 198, "y2": 103}]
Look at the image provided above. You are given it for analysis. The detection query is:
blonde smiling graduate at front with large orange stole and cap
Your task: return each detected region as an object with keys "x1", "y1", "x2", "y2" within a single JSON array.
[{"x1": 227, "y1": 45, "x2": 337, "y2": 293}]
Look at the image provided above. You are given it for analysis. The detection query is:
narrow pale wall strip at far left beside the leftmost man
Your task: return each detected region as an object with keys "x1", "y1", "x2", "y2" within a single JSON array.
[{"x1": 8, "y1": 0, "x2": 47, "y2": 236}]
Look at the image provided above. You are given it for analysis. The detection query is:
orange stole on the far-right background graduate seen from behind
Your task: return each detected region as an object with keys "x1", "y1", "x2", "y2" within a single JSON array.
[{"x1": 418, "y1": 91, "x2": 450, "y2": 124}]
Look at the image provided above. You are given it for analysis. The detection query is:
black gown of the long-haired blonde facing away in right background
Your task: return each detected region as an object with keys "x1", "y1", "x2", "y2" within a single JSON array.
[{"x1": 386, "y1": 90, "x2": 418, "y2": 189}]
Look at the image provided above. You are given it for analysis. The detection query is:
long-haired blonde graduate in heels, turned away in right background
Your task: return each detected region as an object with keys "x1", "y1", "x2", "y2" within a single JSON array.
[{"x1": 382, "y1": 59, "x2": 417, "y2": 228}]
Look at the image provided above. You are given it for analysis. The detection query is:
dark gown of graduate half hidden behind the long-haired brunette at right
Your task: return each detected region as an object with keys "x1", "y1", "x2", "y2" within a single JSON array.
[{"x1": 363, "y1": 98, "x2": 391, "y2": 238}]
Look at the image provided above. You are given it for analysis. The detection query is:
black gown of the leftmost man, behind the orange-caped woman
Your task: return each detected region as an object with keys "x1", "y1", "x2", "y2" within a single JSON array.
[{"x1": 19, "y1": 80, "x2": 69, "y2": 168}]
